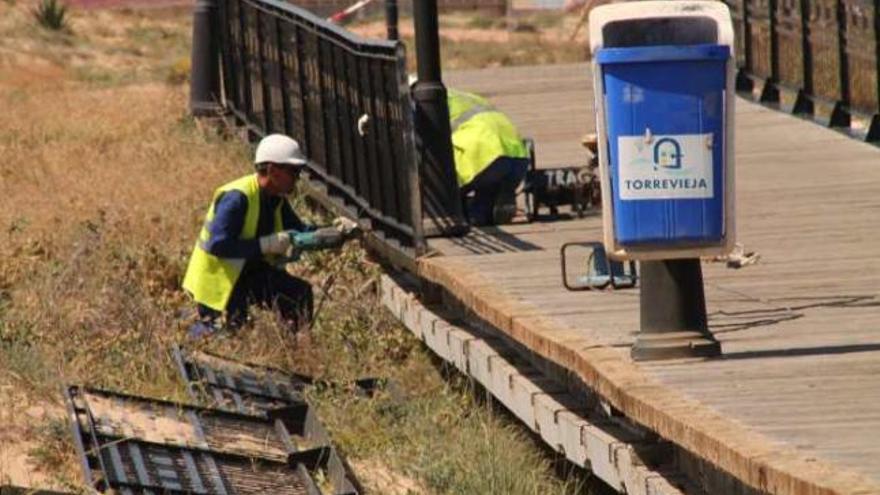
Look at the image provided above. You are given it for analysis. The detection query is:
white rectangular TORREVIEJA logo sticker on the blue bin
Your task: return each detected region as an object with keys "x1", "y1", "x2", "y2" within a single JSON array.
[{"x1": 616, "y1": 134, "x2": 715, "y2": 200}]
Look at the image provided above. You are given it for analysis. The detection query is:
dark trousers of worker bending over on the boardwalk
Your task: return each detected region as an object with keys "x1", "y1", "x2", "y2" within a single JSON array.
[{"x1": 461, "y1": 156, "x2": 529, "y2": 225}]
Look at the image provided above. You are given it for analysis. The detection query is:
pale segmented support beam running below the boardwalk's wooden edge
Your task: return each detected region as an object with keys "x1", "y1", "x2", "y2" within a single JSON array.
[{"x1": 381, "y1": 275, "x2": 700, "y2": 495}]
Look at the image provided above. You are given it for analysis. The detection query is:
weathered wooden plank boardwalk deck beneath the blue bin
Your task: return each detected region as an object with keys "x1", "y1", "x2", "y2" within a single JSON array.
[{"x1": 420, "y1": 64, "x2": 880, "y2": 494}]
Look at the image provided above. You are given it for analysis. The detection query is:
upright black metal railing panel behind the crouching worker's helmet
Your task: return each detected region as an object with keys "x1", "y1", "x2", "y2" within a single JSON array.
[{"x1": 217, "y1": 0, "x2": 424, "y2": 259}]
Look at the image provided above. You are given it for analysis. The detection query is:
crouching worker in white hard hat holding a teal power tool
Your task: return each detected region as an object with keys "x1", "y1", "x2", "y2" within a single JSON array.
[{"x1": 183, "y1": 134, "x2": 357, "y2": 338}]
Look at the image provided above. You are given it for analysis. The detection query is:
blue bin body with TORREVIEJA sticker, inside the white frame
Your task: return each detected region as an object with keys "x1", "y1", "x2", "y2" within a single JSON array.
[{"x1": 596, "y1": 44, "x2": 730, "y2": 248}]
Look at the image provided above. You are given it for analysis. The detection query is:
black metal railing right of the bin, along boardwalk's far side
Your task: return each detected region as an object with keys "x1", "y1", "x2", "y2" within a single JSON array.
[{"x1": 725, "y1": 0, "x2": 880, "y2": 141}]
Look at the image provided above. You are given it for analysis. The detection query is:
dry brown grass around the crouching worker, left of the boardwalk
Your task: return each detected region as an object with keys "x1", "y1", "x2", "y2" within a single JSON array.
[{"x1": 0, "y1": 0, "x2": 600, "y2": 493}]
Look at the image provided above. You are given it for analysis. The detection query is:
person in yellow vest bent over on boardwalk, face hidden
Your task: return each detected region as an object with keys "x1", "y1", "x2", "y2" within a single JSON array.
[{"x1": 447, "y1": 89, "x2": 529, "y2": 225}]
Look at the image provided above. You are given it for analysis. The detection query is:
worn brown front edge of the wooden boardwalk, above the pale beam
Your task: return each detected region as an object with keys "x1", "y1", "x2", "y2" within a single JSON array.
[{"x1": 419, "y1": 257, "x2": 880, "y2": 495}]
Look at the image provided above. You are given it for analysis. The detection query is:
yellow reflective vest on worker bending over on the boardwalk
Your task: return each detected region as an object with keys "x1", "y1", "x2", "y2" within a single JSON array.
[{"x1": 447, "y1": 89, "x2": 529, "y2": 186}]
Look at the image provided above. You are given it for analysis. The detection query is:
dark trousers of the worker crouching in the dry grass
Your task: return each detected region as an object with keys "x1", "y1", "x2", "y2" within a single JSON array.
[{"x1": 199, "y1": 260, "x2": 314, "y2": 331}]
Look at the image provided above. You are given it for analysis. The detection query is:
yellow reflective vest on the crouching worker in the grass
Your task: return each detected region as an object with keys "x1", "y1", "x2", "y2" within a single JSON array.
[{"x1": 183, "y1": 174, "x2": 284, "y2": 311}]
